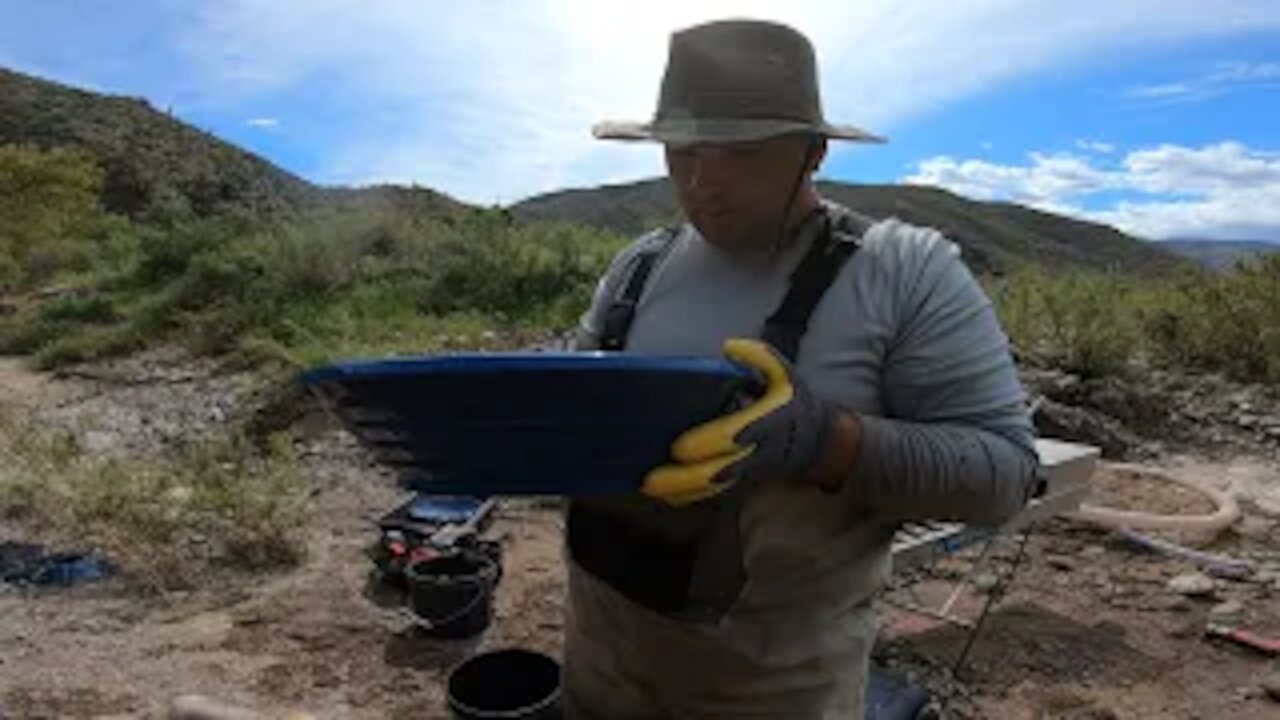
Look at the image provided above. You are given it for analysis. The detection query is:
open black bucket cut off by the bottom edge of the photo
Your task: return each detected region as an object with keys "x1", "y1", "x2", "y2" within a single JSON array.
[{"x1": 449, "y1": 648, "x2": 564, "y2": 720}]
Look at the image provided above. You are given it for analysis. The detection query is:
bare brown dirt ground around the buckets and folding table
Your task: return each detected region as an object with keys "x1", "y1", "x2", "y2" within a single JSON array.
[{"x1": 0, "y1": 360, "x2": 1280, "y2": 720}]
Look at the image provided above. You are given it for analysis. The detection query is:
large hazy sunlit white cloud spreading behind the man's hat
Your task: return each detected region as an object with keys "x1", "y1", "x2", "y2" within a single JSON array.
[{"x1": 180, "y1": 0, "x2": 1280, "y2": 202}]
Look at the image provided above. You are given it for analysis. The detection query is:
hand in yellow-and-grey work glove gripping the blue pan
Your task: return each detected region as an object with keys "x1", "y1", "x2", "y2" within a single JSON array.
[{"x1": 641, "y1": 340, "x2": 858, "y2": 506}]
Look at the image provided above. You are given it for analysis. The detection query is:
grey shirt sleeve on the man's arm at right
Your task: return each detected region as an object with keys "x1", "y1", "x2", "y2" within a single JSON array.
[{"x1": 850, "y1": 223, "x2": 1038, "y2": 527}]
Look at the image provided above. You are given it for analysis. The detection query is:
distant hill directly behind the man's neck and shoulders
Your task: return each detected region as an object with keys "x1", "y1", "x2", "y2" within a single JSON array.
[{"x1": 512, "y1": 179, "x2": 1180, "y2": 272}]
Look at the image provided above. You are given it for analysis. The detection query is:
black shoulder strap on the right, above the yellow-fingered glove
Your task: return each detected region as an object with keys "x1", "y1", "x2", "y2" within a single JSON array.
[{"x1": 760, "y1": 213, "x2": 858, "y2": 363}]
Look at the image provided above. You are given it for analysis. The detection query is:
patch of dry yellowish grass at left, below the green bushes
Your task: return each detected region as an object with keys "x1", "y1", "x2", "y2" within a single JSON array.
[{"x1": 0, "y1": 410, "x2": 307, "y2": 591}]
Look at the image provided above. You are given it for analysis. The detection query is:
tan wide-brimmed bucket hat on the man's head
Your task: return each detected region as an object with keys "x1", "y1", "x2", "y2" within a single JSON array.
[{"x1": 591, "y1": 20, "x2": 884, "y2": 145}]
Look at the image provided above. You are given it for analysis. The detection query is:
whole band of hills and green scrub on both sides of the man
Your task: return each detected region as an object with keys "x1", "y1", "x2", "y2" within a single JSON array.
[{"x1": 12, "y1": 62, "x2": 1280, "y2": 382}]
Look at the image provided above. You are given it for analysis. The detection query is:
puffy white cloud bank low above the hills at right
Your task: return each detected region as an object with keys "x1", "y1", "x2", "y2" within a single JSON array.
[{"x1": 904, "y1": 142, "x2": 1280, "y2": 240}]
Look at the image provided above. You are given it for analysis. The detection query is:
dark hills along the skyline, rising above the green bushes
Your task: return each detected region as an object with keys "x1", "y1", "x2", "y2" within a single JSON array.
[{"x1": 0, "y1": 69, "x2": 1185, "y2": 273}]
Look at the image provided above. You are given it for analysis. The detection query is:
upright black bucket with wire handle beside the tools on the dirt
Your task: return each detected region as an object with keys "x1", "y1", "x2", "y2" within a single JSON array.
[{"x1": 404, "y1": 544, "x2": 502, "y2": 638}]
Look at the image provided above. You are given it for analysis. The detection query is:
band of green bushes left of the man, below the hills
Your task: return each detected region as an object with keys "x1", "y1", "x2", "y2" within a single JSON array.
[{"x1": 0, "y1": 202, "x2": 623, "y2": 364}]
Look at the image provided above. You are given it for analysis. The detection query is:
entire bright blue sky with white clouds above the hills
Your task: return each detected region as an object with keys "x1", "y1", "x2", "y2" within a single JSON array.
[{"x1": 0, "y1": 0, "x2": 1280, "y2": 241}]
